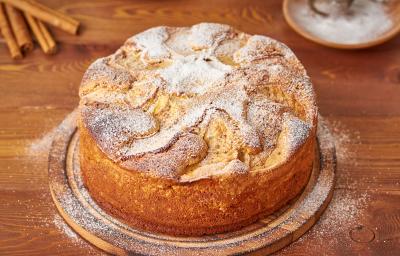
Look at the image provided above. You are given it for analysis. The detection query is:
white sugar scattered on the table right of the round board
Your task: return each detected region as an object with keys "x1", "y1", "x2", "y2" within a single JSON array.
[{"x1": 280, "y1": 119, "x2": 370, "y2": 255}]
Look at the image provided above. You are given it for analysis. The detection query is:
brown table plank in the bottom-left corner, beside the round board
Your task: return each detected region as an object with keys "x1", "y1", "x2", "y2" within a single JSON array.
[{"x1": 0, "y1": 189, "x2": 99, "y2": 255}]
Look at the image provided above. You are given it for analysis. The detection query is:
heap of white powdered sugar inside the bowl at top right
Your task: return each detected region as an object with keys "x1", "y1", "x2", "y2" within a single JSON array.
[{"x1": 293, "y1": 0, "x2": 393, "y2": 44}]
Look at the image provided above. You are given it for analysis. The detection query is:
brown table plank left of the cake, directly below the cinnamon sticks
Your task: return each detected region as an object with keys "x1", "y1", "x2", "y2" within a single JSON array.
[{"x1": 0, "y1": 45, "x2": 117, "y2": 108}]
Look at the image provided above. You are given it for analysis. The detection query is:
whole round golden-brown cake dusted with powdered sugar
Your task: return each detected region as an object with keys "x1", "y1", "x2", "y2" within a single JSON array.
[{"x1": 78, "y1": 23, "x2": 317, "y2": 236}]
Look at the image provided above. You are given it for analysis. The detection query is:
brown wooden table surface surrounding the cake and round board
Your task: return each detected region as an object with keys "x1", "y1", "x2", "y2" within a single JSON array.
[{"x1": 0, "y1": 0, "x2": 400, "y2": 255}]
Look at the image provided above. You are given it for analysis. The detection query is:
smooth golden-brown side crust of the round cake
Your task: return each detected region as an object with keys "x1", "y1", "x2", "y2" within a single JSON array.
[{"x1": 80, "y1": 119, "x2": 315, "y2": 236}]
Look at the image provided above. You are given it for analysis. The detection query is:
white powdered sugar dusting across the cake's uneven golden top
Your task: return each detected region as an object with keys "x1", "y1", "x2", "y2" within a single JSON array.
[{"x1": 80, "y1": 23, "x2": 316, "y2": 177}]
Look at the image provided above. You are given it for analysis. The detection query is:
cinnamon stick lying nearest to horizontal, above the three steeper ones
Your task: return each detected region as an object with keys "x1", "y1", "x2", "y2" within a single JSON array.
[{"x1": 2, "y1": 0, "x2": 79, "y2": 35}]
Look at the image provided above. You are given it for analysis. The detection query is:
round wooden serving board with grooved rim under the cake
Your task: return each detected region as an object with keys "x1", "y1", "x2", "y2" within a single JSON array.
[{"x1": 49, "y1": 111, "x2": 336, "y2": 255}]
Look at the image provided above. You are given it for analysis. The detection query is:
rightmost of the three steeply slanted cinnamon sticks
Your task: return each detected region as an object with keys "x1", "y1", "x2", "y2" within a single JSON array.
[{"x1": 24, "y1": 13, "x2": 56, "y2": 54}]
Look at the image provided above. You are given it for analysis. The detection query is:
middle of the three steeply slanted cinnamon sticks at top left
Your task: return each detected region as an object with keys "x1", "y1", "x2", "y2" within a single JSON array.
[{"x1": 5, "y1": 4, "x2": 33, "y2": 52}]
